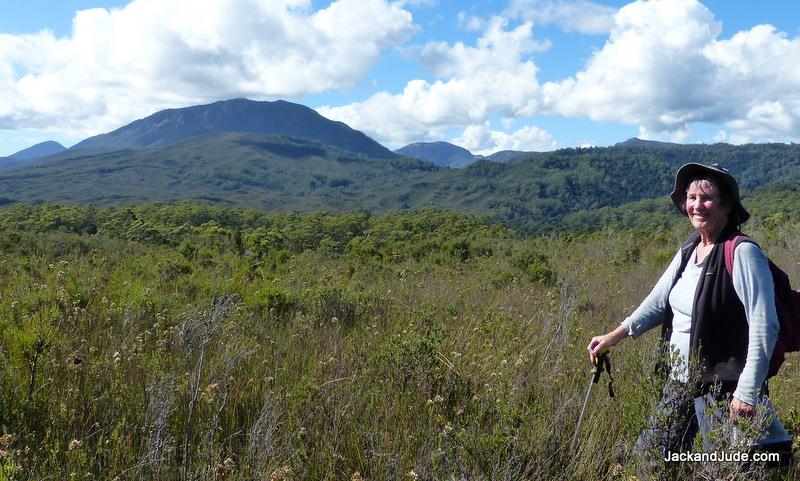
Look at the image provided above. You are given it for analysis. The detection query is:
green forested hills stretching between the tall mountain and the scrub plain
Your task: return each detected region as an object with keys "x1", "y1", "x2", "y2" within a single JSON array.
[{"x1": 0, "y1": 137, "x2": 800, "y2": 234}]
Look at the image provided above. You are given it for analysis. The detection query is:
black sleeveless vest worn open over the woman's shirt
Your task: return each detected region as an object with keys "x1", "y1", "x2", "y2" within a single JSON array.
[{"x1": 661, "y1": 226, "x2": 748, "y2": 386}]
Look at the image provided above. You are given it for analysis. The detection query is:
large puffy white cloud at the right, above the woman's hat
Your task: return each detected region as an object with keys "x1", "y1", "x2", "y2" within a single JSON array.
[{"x1": 542, "y1": 0, "x2": 800, "y2": 142}]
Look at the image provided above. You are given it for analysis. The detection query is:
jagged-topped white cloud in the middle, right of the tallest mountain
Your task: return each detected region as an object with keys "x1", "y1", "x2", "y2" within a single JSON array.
[{"x1": 317, "y1": 17, "x2": 546, "y2": 146}]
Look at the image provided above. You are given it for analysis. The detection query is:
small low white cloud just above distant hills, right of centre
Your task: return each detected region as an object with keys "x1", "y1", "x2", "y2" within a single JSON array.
[{"x1": 453, "y1": 122, "x2": 559, "y2": 155}]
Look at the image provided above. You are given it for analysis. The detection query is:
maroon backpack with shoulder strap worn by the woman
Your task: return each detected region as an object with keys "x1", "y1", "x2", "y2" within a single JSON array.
[{"x1": 725, "y1": 234, "x2": 800, "y2": 378}]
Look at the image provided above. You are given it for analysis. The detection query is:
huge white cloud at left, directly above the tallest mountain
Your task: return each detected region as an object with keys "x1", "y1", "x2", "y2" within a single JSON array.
[{"x1": 0, "y1": 0, "x2": 414, "y2": 139}]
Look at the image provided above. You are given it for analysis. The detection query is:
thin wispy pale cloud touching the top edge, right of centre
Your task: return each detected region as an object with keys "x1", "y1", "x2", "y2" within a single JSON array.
[{"x1": 507, "y1": 0, "x2": 616, "y2": 34}]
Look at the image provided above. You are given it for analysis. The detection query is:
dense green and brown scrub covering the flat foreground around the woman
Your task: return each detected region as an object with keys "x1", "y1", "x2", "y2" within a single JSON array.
[{"x1": 0, "y1": 204, "x2": 800, "y2": 480}]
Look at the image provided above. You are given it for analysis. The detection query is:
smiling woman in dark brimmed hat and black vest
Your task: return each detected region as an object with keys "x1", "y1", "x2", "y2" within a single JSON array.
[{"x1": 587, "y1": 163, "x2": 791, "y2": 451}]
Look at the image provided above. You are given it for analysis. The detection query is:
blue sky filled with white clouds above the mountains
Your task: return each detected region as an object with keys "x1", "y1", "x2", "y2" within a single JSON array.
[{"x1": 0, "y1": 0, "x2": 800, "y2": 156}]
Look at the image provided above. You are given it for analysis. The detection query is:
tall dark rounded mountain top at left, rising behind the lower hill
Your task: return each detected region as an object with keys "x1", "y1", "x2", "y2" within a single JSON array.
[{"x1": 71, "y1": 99, "x2": 397, "y2": 159}]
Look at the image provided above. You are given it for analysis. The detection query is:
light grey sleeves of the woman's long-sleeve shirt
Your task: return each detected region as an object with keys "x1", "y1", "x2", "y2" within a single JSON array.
[{"x1": 622, "y1": 242, "x2": 779, "y2": 405}]
